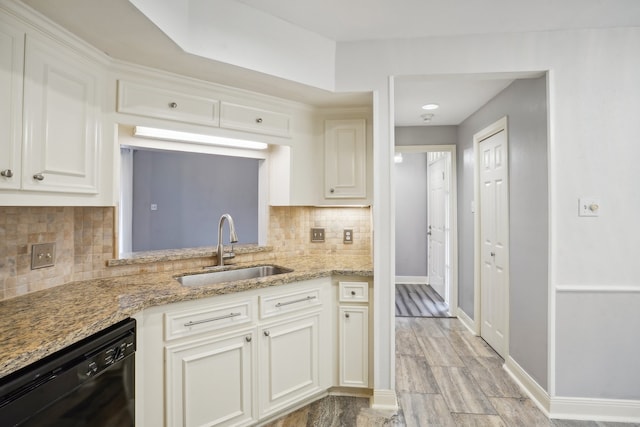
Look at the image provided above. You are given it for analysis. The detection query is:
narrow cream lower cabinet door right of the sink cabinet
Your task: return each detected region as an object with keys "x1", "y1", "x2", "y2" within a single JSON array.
[{"x1": 339, "y1": 306, "x2": 369, "y2": 387}]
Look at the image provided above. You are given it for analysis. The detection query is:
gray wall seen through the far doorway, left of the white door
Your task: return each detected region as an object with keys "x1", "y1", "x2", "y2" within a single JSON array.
[{"x1": 395, "y1": 153, "x2": 429, "y2": 276}]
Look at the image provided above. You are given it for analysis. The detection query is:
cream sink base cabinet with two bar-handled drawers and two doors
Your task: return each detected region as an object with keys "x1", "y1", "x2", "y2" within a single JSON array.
[{"x1": 141, "y1": 278, "x2": 335, "y2": 427}]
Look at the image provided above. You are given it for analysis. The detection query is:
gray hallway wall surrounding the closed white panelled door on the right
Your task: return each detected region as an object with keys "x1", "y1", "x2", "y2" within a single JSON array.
[{"x1": 458, "y1": 77, "x2": 549, "y2": 389}]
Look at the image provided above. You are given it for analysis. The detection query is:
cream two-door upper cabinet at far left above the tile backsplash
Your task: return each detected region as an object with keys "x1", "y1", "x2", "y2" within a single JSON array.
[{"x1": 0, "y1": 13, "x2": 106, "y2": 199}]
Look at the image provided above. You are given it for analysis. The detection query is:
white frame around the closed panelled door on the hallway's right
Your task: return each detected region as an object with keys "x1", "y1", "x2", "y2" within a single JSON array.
[{"x1": 473, "y1": 116, "x2": 511, "y2": 360}]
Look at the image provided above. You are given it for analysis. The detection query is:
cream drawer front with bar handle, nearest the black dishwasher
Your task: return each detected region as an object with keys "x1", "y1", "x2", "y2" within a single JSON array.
[{"x1": 164, "y1": 299, "x2": 253, "y2": 341}]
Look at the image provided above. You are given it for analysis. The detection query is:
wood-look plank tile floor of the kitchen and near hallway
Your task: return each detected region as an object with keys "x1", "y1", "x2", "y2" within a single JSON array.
[{"x1": 268, "y1": 317, "x2": 640, "y2": 427}]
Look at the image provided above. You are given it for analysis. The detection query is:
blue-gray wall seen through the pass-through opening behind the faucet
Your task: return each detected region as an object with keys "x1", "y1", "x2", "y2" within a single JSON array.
[{"x1": 132, "y1": 150, "x2": 258, "y2": 251}]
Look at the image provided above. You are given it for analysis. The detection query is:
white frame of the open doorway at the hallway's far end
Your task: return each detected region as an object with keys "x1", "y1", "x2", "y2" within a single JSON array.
[{"x1": 393, "y1": 144, "x2": 461, "y2": 317}]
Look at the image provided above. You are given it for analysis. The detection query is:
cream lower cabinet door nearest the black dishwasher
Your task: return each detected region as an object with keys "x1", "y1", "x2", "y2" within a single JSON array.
[{"x1": 165, "y1": 330, "x2": 255, "y2": 427}]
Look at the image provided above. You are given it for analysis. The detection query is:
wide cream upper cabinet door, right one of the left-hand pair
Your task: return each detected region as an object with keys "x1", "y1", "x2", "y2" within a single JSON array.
[{"x1": 22, "y1": 37, "x2": 102, "y2": 193}]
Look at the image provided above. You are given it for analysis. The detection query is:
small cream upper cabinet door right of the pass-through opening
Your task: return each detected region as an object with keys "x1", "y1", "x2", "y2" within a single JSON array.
[{"x1": 324, "y1": 119, "x2": 367, "y2": 199}]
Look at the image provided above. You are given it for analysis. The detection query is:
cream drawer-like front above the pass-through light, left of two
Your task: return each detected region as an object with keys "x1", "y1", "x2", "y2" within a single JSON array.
[{"x1": 118, "y1": 81, "x2": 219, "y2": 126}]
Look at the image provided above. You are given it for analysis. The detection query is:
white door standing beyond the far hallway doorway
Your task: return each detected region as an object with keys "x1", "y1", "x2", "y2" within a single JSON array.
[{"x1": 427, "y1": 152, "x2": 449, "y2": 304}]
